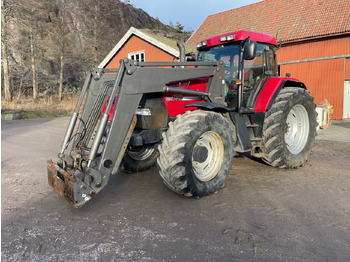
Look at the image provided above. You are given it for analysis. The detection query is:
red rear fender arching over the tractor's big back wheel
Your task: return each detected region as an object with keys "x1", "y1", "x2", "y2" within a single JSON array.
[{"x1": 254, "y1": 77, "x2": 306, "y2": 113}]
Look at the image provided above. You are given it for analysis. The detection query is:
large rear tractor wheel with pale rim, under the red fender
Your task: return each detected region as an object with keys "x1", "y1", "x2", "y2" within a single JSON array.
[{"x1": 263, "y1": 87, "x2": 317, "y2": 169}]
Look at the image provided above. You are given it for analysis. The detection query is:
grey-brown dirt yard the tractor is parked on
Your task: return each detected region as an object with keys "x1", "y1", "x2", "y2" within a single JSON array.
[{"x1": 1, "y1": 118, "x2": 350, "y2": 261}]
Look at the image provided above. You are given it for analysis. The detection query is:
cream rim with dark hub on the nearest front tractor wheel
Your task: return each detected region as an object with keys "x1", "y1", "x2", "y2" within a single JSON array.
[{"x1": 192, "y1": 131, "x2": 224, "y2": 181}]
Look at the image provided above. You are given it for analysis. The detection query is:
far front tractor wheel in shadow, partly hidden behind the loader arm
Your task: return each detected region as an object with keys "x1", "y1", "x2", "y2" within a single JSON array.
[{"x1": 120, "y1": 145, "x2": 159, "y2": 173}]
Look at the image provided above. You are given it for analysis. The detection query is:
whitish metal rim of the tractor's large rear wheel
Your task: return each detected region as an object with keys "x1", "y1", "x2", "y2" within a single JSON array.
[{"x1": 284, "y1": 105, "x2": 309, "y2": 154}]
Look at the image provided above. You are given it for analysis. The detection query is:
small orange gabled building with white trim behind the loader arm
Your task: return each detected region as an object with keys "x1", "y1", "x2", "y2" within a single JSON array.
[{"x1": 98, "y1": 27, "x2": 196, "y2": 68}]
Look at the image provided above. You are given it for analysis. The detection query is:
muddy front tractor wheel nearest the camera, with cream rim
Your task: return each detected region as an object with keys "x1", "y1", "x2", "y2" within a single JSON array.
[{"x1": 157, "y1": 111, "x2": 234, "y2": 197}]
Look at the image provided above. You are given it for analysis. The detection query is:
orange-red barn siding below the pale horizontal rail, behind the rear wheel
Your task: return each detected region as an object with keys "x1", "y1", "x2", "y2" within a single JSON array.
[{"x1": 281, "y1": 58, "x2": 344, "y2": 119}]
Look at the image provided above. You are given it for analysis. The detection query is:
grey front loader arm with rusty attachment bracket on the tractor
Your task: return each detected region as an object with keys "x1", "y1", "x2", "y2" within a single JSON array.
[{"x1": 47, "y1": 59, "x2": 224, "y2": 207}]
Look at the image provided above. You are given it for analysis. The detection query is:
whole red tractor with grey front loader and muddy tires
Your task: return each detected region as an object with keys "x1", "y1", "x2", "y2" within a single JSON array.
[{"x1": 47, "y1": 31, "x2": 316, "y2": 207}]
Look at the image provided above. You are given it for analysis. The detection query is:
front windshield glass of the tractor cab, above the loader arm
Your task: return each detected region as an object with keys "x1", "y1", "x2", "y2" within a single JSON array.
[{"x1": 197, "y1": 44, "x2": 240, "y2": 83}]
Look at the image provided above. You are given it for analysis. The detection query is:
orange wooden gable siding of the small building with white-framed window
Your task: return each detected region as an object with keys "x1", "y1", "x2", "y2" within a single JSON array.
[{"x1": 105, "y1": 35, "x2": 174, "y2": 68}]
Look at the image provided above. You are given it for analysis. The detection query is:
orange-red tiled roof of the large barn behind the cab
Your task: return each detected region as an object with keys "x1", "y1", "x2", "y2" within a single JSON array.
[{"x1": 187, "y1": 0, "x2": 350, "y2": 44}]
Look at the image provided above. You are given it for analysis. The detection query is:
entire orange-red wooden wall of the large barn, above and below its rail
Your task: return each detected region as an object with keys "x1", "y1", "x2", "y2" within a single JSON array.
[{"x1": 277, "y1": 35, "x2": 350, "y2": 119}]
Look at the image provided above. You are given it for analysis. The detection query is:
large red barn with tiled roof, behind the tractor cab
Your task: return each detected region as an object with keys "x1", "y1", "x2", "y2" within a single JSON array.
[{"x1": 187, "y1": 0, "x2": 350, "y2": 119}]
